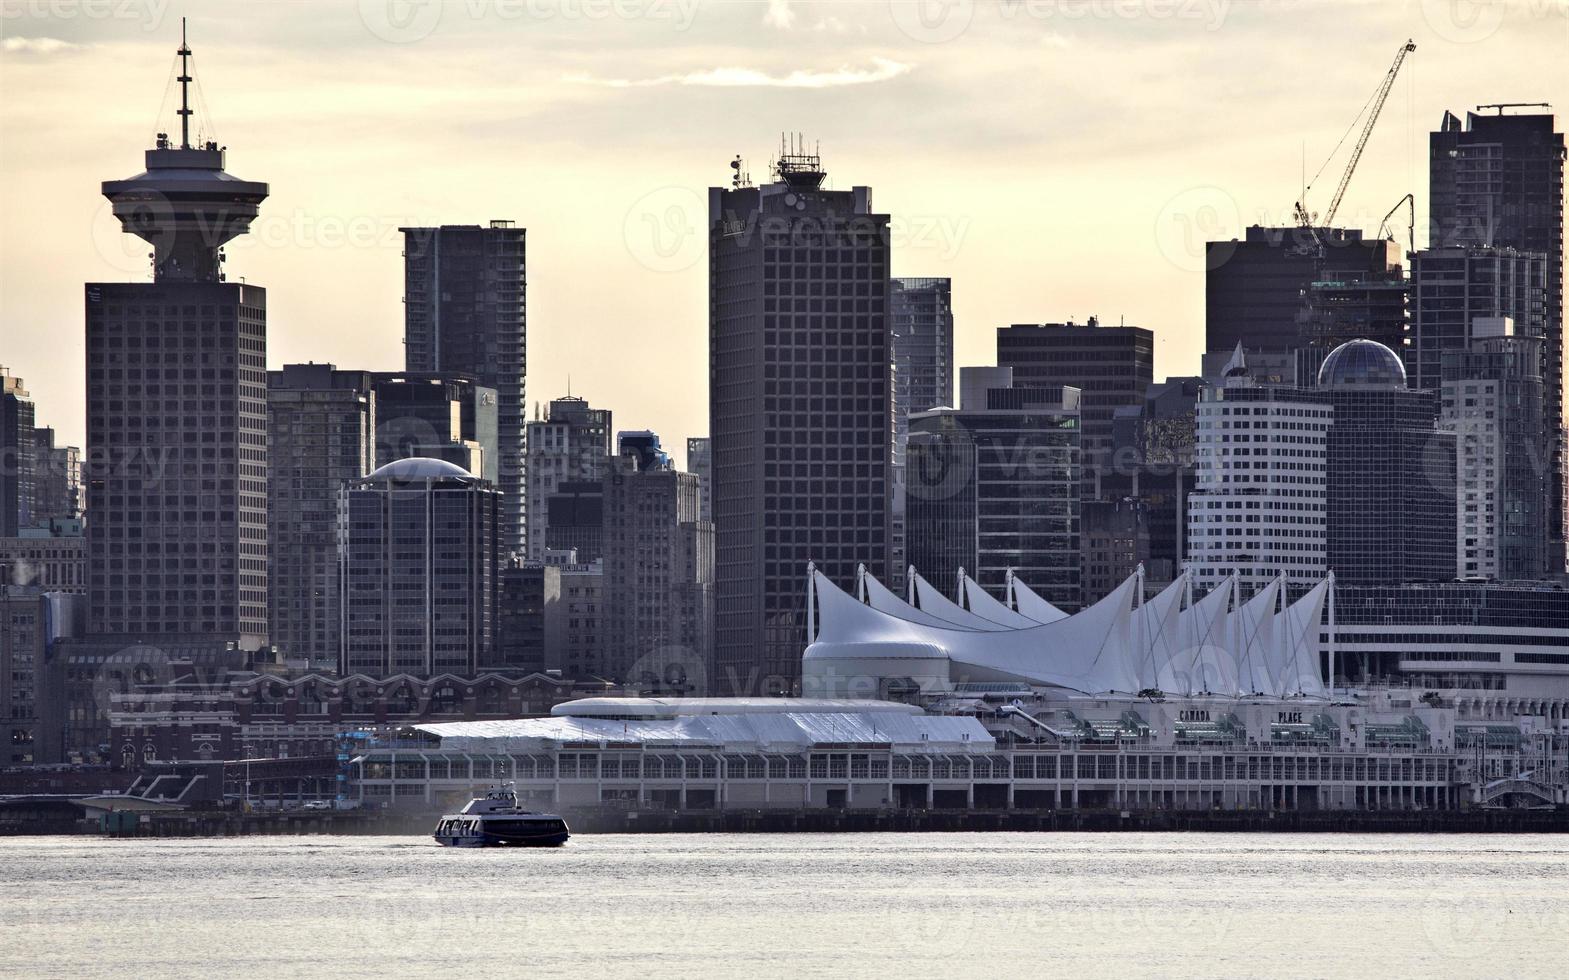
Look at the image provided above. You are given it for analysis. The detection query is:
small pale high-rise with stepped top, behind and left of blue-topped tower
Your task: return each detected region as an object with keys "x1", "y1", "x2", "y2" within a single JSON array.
[{"x1": 527, "y1": 395, "x2": 610, "y2": 561}]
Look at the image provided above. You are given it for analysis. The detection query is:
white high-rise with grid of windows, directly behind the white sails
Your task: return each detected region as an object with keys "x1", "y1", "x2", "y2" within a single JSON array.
[{"x1": 1188, "y1": 351, "x2": 1335, "y2": 591}]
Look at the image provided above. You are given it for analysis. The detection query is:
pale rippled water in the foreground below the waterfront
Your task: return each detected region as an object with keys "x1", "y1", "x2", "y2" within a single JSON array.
[{"x1": 0, "y1": 834, "x2": 1569, "y2": 980}]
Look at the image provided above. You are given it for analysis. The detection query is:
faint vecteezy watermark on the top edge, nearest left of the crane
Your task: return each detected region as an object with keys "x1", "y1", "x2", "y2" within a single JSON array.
[{"x1": 888, "y1": 0, "x2": 1233, "y2": 44}]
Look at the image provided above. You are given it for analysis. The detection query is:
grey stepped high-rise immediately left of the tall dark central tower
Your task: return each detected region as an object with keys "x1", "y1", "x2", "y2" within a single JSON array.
[{"x1": 604, "y1": 453, "x2": 714, "y2": 684}]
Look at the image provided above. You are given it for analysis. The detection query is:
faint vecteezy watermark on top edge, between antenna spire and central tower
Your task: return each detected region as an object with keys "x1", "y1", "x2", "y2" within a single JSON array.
[{"x1": 359, "y1": 0, "x2": 701, "y2": 44}]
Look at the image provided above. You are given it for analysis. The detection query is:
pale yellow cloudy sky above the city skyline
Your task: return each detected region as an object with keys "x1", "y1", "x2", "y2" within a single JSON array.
[{"x1": 0, "y1": 0, "x2": 1569, "y2": 458}]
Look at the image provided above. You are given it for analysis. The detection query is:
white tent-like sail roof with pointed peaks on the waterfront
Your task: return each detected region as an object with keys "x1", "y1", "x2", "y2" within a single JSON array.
[{"x1": 802, "y1": 568, "x2": 1334, "y2": 698}]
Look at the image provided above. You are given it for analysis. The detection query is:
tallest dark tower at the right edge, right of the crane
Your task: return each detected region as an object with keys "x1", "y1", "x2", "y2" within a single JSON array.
[{"x1": 1428, "y1": 105, "x2": 1569, "y2": 571}]
